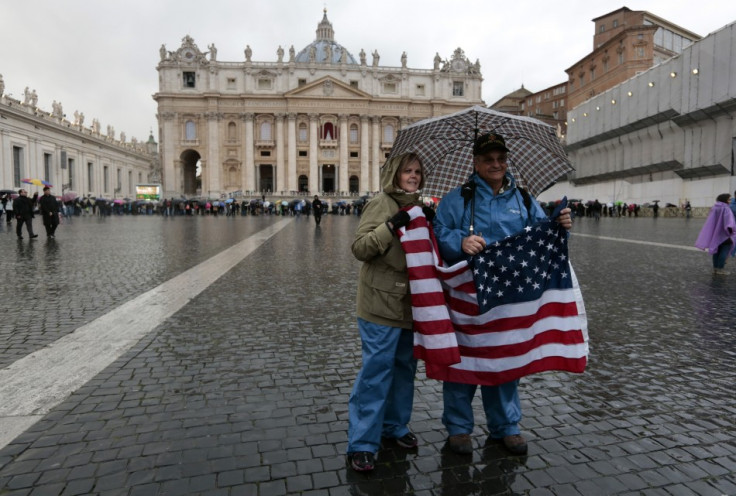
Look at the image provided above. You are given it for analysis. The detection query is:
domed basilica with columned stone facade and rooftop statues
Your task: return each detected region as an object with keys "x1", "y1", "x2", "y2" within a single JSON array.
[{"x1": 154, "y1": 10, "x2": 483, "y2": 196}]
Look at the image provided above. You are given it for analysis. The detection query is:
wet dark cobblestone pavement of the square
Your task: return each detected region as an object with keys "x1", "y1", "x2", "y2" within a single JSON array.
[{"x1": 0, "y1": 215, "x2": 736, "y2": 496}]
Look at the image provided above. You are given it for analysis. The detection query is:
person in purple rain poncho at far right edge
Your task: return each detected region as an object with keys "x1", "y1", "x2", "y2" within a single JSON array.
[{"x1": 695, "y1": 193, "x2": 736, "y2": 275}]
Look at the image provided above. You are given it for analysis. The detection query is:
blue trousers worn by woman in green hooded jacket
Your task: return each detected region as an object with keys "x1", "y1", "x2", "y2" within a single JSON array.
[{"x1": 347, "y1": 318, "x2": 417, "y2": 454}]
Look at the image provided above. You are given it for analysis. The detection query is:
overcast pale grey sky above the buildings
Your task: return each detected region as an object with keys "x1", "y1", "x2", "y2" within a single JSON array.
[{"x1": 0, "y1": 0, "x2": 736, "y2": 140}]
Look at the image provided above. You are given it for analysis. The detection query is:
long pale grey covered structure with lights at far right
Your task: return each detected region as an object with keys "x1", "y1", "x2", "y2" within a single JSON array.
[{"x1": 541, "y1": 18, "x2": 736, "y2": 209}]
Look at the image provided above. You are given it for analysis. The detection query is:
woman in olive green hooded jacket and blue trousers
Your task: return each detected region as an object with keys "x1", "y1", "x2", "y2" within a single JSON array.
[{"x1": 347, "y1": 153, "x2": 424, "y2": 472}]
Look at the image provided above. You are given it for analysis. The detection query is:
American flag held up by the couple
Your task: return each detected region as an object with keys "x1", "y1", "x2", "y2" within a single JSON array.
[{"x1": 400, "y1": 203, "x2": 588, "y2": 385}]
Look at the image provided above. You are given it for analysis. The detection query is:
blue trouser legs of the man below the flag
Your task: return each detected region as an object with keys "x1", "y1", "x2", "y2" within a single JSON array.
[{"x1": 442, "y1": 380, "x2": 521, "y2": 439}]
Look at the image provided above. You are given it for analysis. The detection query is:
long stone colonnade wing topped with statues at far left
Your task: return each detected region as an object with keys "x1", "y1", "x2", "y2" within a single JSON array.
[{"x1": 0, "y1": 80, "x2": 160, "y2": 199}]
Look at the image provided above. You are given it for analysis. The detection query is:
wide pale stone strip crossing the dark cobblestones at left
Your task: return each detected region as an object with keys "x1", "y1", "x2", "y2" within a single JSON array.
[{"x1": 0, "y1": 218, "x2": 293, "y2": 449}]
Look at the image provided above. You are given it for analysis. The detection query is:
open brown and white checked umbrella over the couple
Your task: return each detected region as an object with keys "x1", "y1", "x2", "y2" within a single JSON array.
[{"x1": 389, "y1": 105, "x2": 575, "y2": 196}]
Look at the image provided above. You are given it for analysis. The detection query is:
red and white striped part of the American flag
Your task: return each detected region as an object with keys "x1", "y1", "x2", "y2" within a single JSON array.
[{"x1": 399, "y1": 207, "x2": 588, "y2": 385}]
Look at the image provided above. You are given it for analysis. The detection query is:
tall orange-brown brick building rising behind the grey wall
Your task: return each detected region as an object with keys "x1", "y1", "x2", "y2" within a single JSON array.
[{"x1": 565, "y1": 7, "x2": 701, "y2": 109}]
